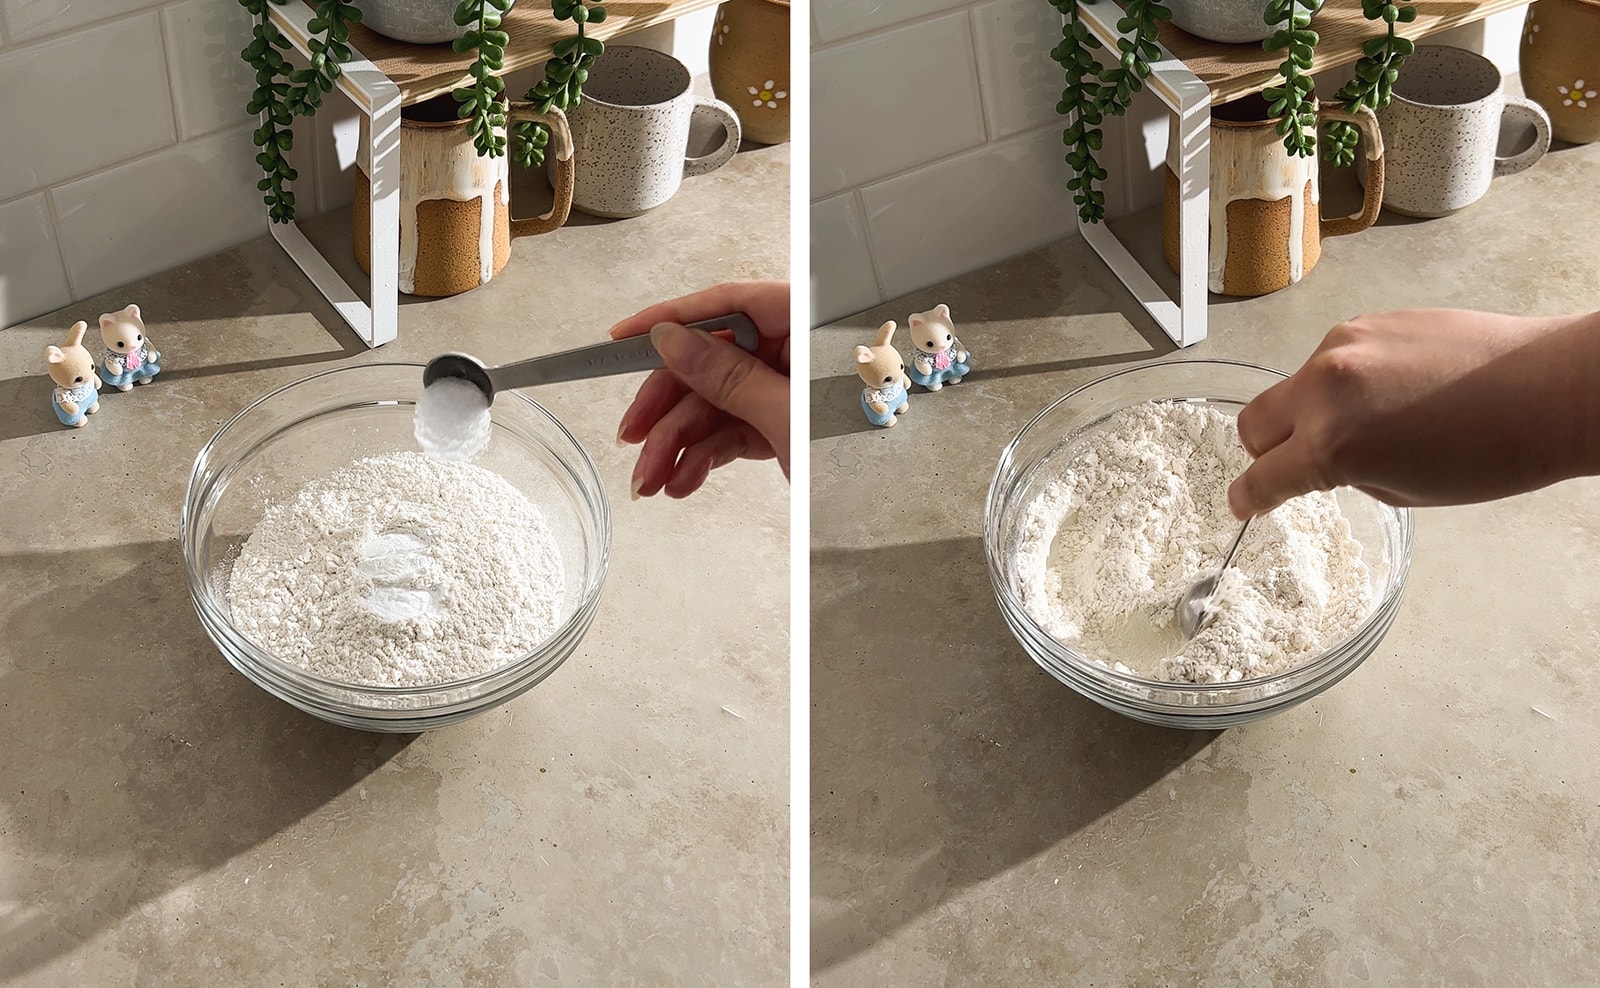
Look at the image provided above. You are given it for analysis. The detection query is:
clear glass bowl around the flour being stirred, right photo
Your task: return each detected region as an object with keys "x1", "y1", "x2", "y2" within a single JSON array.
[{"x1": 984, "y1": 360, "x2": 1413, "y2": 729}]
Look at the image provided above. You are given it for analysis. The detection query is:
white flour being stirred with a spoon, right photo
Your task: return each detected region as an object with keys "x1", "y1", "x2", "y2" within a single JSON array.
[{"x1": 1014, "y1": 396, "x2": 1373, "y2": 683}]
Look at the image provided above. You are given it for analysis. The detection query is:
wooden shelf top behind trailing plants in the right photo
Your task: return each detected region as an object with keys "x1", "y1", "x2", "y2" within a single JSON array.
[{"x1": 1160, "y1": 0, "x2": 1526, "y2": 102}]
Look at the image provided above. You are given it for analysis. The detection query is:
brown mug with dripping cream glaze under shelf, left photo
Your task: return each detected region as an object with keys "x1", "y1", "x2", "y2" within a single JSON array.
[{"x1": 352, "y1": 94, "x2": 574, "y2": 296}]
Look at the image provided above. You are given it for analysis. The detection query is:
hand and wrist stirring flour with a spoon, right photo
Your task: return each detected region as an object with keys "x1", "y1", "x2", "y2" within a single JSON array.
[{"x1": 1229, "y1": 309, "x2": 1600, "y2": 518}]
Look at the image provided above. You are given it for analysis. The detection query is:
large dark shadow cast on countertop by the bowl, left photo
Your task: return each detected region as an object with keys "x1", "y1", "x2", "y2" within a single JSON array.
[{"x1": 0, "y1": 540, "x2": 416, "y2": 982}]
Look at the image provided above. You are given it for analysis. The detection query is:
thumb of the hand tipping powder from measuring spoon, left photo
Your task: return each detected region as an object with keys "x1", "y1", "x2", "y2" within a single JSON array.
[{"x1": 650, "y1": 323, "x2": 789, "y2": 444}]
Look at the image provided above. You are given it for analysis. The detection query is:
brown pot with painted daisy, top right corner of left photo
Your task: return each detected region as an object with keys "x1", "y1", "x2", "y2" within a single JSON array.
[{"x1": 710, "y1": 0, "x2": 792, "y2": 144}]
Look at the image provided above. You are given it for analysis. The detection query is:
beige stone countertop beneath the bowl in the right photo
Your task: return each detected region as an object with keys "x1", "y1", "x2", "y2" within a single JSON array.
[{"x1": 811, "y1": 136, "x2": 1600, "y2": 988}]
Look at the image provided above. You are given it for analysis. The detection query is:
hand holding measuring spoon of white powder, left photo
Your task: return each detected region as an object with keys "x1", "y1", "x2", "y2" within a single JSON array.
[{"x1": 611, "y1": 281, "x2": 789, "y2": 499}]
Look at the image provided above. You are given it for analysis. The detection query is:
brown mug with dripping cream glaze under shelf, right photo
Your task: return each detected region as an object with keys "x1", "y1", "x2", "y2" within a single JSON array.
[{"x1": 1162, "y1": 96, "x2": 1384, "y2": 296}]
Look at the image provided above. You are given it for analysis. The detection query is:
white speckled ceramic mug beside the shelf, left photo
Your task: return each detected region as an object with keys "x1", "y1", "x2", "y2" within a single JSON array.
[{"x1": 566, "y1": 45, "x2": 739, "y2": 217}]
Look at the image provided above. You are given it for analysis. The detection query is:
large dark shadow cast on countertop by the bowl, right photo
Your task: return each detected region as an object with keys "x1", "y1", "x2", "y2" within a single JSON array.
[{"x1": 811, "y1": 537, "x2": 1219, "y2": 974}]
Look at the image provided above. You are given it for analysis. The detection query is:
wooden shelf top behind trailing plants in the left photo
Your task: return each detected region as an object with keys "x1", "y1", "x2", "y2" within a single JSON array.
[{"x1": 331, "y1": 0, "x2": 720, "y2": 106}]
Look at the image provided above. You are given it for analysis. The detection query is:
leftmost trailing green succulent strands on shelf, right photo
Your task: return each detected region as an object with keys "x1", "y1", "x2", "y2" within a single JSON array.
[{"x1": 1050, "y1": 0, "x2": 1173, "y2": 222}]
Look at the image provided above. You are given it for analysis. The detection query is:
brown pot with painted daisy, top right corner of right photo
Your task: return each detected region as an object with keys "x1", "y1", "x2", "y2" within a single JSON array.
[{"x1": 1517, "y1": 0, "x2": 1600, "y2": 144}]
